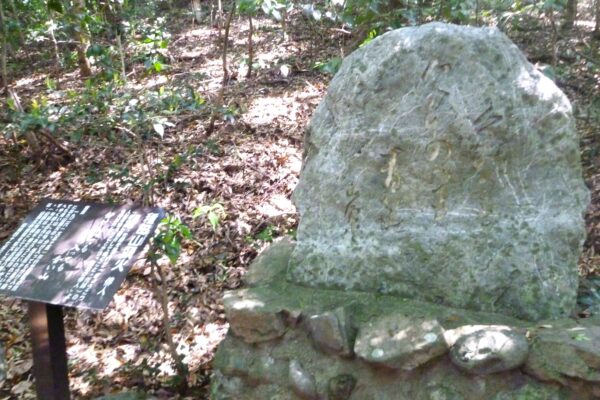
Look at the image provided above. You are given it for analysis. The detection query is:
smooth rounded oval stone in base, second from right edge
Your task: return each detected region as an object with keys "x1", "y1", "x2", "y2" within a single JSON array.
[{"x1": 450, "y1": 327, "x2": 529, "y2": 374}]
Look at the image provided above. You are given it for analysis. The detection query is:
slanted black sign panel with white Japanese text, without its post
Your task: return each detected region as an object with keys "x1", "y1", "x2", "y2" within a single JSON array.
[{"x1": 0, "y1": 199, "x2": 163, "y2": 310}]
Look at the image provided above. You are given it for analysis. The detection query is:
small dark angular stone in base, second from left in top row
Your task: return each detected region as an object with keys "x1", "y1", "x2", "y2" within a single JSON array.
[{"x1": 306, "y1": 307, "x2": 356, "y2": 356}]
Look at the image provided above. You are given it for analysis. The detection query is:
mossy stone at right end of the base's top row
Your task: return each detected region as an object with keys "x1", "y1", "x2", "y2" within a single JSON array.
[{"x1": 525, "y1": 326, "x2": 600, "y2": 385}]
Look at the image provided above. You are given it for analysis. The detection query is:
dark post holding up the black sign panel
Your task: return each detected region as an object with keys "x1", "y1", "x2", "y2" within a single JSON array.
[{"x1": 28, "y1": 301, "x2": 71, "y2": 400}]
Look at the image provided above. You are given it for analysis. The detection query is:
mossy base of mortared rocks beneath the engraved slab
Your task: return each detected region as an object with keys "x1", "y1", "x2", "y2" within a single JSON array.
[{"x1": 211, "y1": 241, "x2": 600, "y2": 400}]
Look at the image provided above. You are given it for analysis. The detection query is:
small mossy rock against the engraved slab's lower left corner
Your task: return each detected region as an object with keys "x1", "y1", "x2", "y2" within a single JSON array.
[{"x1": 243, "y1": 237, "x2": 295, "y2": 286}]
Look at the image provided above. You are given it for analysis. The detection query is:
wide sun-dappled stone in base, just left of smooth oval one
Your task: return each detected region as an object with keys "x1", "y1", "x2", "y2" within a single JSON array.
[{"x1": 354, "y1": 315, "x2": 448, "y2": 371}]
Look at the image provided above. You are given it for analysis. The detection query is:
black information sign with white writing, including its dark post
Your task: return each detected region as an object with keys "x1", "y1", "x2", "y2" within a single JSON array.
[{"x1": 0, "y1": 199, "x2": 163, "y2": 400}]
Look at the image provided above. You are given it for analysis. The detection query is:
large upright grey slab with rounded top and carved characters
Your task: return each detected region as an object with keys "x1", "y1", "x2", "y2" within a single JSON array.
[{"x1": 287, "y1": 23, "x2": 589, "y2": 320}]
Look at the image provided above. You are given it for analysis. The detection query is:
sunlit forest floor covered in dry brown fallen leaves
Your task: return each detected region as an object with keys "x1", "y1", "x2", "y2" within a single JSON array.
[{"x1": 0, "y1": 6, "x2": 600, "y2": 400}]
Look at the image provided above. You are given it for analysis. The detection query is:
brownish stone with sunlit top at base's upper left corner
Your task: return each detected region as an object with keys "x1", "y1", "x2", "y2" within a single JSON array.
[{"x1": 223, "y1": 291, "x2": 286, "y2": 343}]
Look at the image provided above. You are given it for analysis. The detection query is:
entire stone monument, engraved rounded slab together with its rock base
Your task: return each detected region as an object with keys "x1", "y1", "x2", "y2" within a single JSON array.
[{"x1": 213, "y1": 23, "x2": 600, "y2": 400}]
